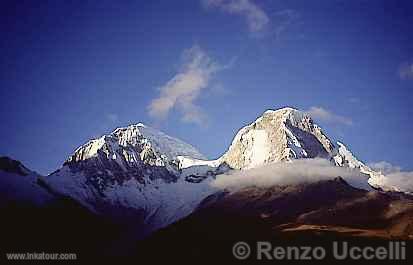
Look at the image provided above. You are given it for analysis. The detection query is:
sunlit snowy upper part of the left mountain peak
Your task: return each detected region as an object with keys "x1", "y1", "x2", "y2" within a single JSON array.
[{"x1": 65, "y1": 123, "x2": 205, "y2": 170}]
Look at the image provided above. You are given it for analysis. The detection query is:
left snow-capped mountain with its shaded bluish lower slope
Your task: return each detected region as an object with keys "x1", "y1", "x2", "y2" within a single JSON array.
[{"x1": 44, "y1": 123, "x2": 214, "y2": 234}]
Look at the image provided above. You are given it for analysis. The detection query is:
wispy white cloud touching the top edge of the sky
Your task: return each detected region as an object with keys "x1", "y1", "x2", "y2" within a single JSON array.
[{"x1": 202, "y1": 0, "x2": 270, "y2": 32}]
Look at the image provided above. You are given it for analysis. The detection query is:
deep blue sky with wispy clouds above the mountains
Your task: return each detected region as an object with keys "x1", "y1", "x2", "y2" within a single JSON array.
[{"x1": 0, "y1": 0, "x2": 413, "y2": 174}]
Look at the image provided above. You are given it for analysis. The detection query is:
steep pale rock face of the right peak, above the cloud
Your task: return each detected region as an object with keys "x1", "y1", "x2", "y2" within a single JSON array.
[{"x1": 220, "y1": 108, "x2": 334, "y2": 169}]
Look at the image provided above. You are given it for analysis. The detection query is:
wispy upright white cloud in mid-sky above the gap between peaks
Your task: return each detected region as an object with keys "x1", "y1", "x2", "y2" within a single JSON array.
[{"x1": 148, "y1": 45, "x2": 220, "y2": 125}]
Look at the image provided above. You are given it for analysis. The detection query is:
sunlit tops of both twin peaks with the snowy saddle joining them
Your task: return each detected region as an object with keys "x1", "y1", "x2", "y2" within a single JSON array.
[{"x1": 60, "y1": 108, "x2": 361, "y2": 174}]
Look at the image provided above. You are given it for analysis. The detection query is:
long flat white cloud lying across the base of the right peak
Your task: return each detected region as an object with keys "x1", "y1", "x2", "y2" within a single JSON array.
[{"x1": 212, "y1": 158, "x2": 370, "y2": 190}]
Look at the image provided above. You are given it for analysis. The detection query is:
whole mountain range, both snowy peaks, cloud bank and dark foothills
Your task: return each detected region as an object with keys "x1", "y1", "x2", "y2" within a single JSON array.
[{"x1": 0, "y1": 108, "x2": 413, "y2": 260}]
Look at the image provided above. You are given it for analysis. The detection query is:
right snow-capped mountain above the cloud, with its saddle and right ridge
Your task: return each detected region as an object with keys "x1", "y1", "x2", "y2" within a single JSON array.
[{"x1": 179, "y1": 107, "x2": 390, "y2": 191}]
